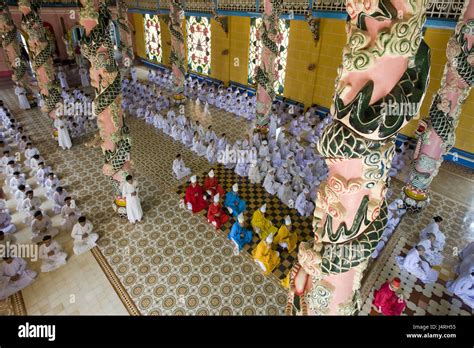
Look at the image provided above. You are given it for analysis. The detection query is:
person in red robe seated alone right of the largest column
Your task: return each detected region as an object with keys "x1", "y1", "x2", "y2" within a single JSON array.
[{"x1": 372, "y1": 278, "x2": 406, "y2": 315}]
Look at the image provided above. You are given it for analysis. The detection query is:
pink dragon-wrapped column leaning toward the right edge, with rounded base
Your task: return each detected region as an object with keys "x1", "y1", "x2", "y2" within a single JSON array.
[{"x1": 402, "y1": 0, "x2": 474, "y2": 211}]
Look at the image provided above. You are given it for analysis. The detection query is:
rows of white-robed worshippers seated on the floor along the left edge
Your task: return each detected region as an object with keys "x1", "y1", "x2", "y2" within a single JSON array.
[{"x1": 0, "y1": 101, "x2": 99, "y2": 300}]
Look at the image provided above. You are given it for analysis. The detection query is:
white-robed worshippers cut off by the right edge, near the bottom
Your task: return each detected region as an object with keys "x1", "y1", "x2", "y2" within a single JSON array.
[{"x1": 446, "y1": 242, "x2": 474, "y2": 309}]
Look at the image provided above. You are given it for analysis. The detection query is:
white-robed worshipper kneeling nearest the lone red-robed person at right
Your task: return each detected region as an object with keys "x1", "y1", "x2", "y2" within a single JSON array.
[{"x1": 396, "y1": 245, "x2": 438, "y2": 284}]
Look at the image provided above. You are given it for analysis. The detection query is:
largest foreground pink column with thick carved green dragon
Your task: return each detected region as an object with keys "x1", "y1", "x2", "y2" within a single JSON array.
[{"x1": 287, "y1": 0, "x2": 430, "y2": 315}]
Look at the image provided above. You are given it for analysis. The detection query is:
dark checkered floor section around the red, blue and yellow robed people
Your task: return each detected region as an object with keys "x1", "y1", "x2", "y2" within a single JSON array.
[{"x1": 176, "y1": 165, "x2": 313, "y2": 279}]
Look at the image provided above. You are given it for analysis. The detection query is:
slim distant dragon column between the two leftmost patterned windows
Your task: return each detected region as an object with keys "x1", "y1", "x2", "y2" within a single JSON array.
[{"x1": 169, "y1": 0, "x2": 186, "y2": 104}]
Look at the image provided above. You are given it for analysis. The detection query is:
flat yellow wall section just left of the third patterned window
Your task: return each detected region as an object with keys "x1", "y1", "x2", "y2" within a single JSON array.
[{"x1": 228, "y1": 17, "x2": 250, "y2": 85}]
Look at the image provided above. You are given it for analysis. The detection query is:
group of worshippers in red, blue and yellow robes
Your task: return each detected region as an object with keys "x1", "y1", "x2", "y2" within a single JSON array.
[{"x1": 182, "y1": 169, "x2": 298, "y2": 274}]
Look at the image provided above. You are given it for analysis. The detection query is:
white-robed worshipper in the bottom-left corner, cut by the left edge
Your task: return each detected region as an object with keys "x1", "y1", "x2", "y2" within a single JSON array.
[{"x1": 0, "y1": 256, "x2": 37, "y2": 300}]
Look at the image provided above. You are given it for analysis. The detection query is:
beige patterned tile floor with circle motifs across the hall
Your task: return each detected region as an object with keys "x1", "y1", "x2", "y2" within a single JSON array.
[{"x1": 0, "y1": 63, "x2": 474, "y2": 315}]
